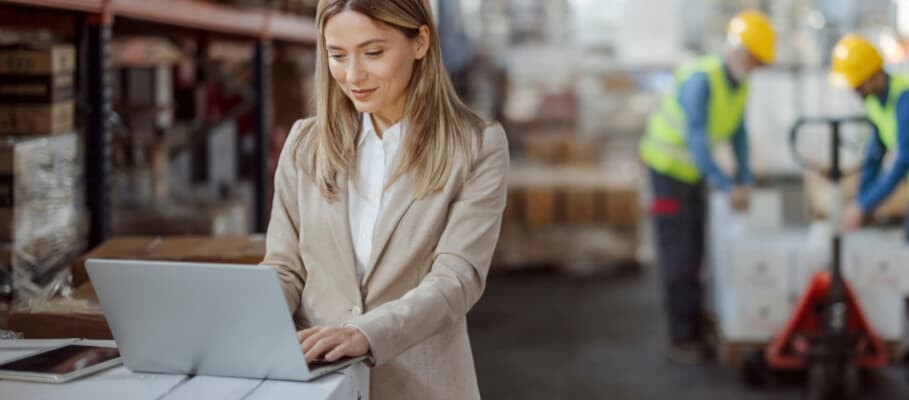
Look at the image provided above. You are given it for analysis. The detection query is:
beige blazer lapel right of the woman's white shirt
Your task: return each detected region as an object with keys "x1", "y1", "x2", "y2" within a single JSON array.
[{"x1": 363, "y1": 172, "x2": 415, "y2": 286}]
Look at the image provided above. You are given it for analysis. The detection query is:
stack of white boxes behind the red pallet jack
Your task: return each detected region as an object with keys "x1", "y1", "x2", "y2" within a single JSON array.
[{"x1": 709, "y1": 191, "x2": 909, "y2": 362}]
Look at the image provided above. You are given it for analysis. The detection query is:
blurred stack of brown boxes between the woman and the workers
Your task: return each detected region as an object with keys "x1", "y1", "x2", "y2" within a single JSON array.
[{"x1": 494, "y1": 139, "x2": 641, "y2": 274}]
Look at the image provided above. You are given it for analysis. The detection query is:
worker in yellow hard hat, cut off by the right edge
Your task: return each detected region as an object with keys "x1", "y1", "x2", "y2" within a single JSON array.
[{"x1": 830, "y1": 34, "x2": 909, "y2": 236}]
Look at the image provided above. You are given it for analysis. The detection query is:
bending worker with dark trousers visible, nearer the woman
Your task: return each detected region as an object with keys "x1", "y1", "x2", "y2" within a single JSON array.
[{"x1": 640, "y1": 11, "x2": 774, "y2": 364}]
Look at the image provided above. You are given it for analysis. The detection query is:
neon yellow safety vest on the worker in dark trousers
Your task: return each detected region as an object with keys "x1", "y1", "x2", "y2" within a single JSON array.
[{"x1": 639, "y1": 56, "x2": 748, "y2": 184}]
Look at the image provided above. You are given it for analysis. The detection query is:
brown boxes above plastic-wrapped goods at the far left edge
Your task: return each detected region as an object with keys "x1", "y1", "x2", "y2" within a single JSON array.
[{"x1": 0, "y1": 44, "x2": 85, "y2": 326}]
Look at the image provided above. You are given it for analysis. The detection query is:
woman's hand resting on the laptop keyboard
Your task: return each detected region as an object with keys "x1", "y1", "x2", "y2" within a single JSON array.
[{"x1": 297, "y1": 326, "x2": 369, "y2": 362}]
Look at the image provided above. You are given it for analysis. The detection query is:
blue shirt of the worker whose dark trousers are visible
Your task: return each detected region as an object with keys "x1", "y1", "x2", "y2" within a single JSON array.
[{"x1": 679, "y1": 67, "x2": 754, "y2": 191}]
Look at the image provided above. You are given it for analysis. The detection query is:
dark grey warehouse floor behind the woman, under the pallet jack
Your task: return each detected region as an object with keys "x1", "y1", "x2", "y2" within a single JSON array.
[{"x1": 468, "y1": 269, "x2": 909, "y2": 400}]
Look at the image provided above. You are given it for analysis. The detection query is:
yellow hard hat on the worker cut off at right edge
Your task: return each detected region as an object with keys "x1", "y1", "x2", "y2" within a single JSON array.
[{"x1": 830, "y1": 33, "x2": 884, "y2": 89}]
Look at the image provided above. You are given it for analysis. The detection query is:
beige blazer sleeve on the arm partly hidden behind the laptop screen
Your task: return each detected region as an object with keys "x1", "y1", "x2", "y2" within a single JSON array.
[{"x1": 261, "y1": 120, "x2": 306, "y2": 314}]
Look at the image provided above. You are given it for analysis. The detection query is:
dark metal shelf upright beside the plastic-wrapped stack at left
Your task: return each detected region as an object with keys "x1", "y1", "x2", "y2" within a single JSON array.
[{"x1": 83, "y1": 4, "x2": 113, "y2": 247}]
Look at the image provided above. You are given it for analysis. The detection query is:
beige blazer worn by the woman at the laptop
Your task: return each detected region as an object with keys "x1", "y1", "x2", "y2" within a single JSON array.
[{"x1": 263, "y1": 120, "x2": 509, "y2": 400}]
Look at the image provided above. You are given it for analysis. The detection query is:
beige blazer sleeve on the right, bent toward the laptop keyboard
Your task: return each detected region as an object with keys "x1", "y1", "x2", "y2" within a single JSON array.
[{"x1": 349, "y1": 125, "x2": 509, "y2": 365}]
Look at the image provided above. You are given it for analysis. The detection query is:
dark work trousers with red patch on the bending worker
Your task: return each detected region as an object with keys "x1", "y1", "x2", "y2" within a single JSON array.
[{"x1": 650, "y1": 169, "x2": 707, "y2": 341}]
